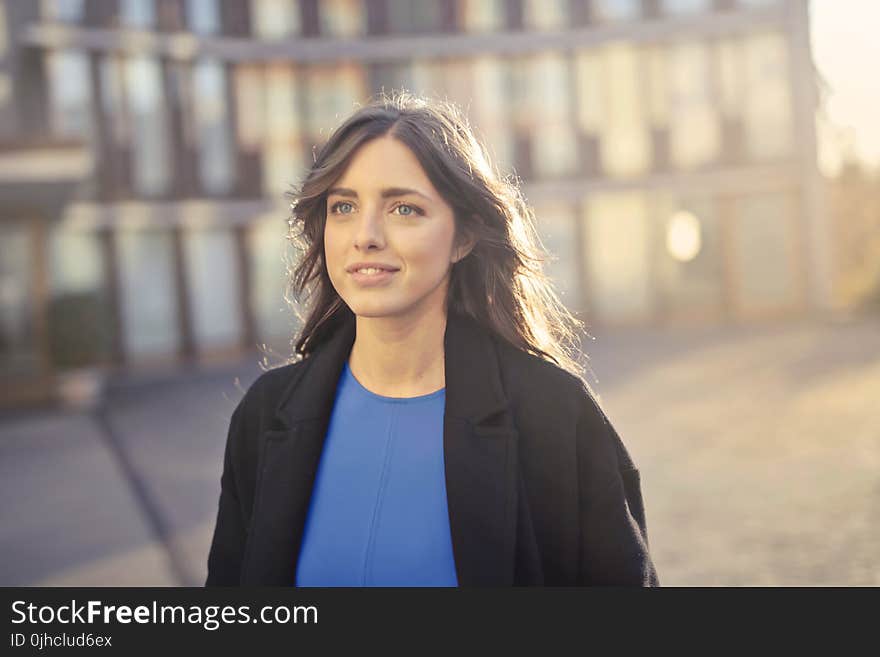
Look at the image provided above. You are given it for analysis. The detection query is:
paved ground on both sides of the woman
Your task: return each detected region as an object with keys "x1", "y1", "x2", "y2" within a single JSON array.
[{"x1": 0, "y1": 318, "x2": 880, "y2": 586}]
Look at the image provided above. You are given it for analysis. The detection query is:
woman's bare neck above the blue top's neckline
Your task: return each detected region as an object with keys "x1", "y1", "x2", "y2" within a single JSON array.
[{"x1": 348, "y1": 310, "x2": 446, "y2": 397}]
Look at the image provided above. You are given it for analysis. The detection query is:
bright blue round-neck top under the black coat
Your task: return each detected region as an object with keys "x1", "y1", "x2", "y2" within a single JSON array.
[{"x1": 296, "y1": 362, "x2": 458, "y2": 586}]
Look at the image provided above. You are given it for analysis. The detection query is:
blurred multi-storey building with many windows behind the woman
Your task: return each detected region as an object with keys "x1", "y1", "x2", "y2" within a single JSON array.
[{"x1": 0, "y1": 0, "x2": 829, "y2": 408}]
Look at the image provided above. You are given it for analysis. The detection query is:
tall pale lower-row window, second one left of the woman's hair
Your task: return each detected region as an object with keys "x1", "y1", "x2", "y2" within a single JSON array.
[{"x1": 184, "y1": 228, "x2": 241, "y2": 351}]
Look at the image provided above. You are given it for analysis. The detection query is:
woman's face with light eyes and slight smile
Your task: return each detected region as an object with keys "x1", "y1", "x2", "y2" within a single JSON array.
[{"x1": 324, "y1": 137, "x2": 455, "y2": 317}]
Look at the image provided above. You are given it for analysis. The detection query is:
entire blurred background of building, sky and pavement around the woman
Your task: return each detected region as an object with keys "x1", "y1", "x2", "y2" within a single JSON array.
[{"x1": 0, "y1": 0, "x2": 880, "y2": 585}]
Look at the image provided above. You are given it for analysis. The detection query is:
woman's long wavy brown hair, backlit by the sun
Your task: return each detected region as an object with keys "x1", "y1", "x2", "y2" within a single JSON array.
[{"x1": 287, "y1": 91, "x2": 590, "y2": 389}]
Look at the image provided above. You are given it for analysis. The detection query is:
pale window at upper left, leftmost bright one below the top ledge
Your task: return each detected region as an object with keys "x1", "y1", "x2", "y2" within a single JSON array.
[{"x1": 46, "y1": 50, "x2": 91, "y2": 139}]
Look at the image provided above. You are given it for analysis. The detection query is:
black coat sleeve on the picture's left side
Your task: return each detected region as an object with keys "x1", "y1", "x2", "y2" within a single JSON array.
[{"x1": 205, "y1": 400, "x2": 247, "y2": 586}]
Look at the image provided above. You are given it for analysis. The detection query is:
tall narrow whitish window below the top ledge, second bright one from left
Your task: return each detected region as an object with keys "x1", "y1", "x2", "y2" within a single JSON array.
[{"x1": 126, "y1": 55, "x2": 170, "y2": 196}]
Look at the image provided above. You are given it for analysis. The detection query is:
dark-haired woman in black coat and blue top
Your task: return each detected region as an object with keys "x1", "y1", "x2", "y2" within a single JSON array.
[{"x1": 207, "y1": 93, "x2": 658, "y2": 586}]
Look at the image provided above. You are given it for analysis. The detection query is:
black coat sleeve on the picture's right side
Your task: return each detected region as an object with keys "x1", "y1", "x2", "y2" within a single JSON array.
[{"x1": 577, "y1": 396, "x2": 660, "y2": 586}]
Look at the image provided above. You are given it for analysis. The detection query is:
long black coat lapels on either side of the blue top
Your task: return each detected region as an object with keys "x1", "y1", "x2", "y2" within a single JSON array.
[{"x1": 242, "y1": 312, "x2": 518, "y2": 586}]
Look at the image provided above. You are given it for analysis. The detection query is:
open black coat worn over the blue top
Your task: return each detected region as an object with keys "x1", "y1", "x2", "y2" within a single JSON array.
[{"x1": 206, "y1": 313, "x2": 659, "y2": 586}]
